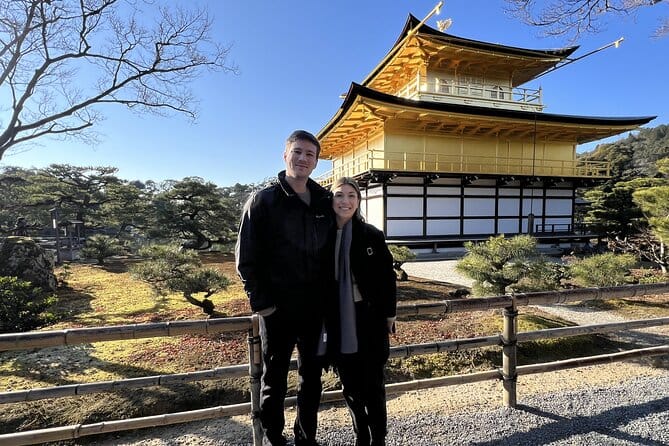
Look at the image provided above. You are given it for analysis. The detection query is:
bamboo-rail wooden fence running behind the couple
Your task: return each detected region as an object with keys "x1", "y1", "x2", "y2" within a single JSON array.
[{"x1": 0, "y1": 283, "x2": 669, "y2": 446}]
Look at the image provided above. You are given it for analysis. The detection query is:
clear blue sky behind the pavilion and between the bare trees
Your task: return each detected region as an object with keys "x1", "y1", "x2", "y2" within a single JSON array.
[{"x1": 0, "y1": 0, "x2": 669, "y2": 186}]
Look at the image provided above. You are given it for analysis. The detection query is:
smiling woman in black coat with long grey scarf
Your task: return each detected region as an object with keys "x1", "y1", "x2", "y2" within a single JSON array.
[{"x1": 328, "y1": 177, "x2": 396, "y2": 446}]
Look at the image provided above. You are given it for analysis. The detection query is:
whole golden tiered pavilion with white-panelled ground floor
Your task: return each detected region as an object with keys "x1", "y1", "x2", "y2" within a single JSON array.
[{"x1": 317, "y1": 15, "x2": 654, "y2": 250}]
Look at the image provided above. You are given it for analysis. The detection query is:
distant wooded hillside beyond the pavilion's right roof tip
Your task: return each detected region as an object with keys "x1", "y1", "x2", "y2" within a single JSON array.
[{"x1": 579, "y1": 124, "x2": 669, "y2": 183}]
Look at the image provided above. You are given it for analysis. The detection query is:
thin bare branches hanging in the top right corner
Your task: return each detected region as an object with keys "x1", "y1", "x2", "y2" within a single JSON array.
[{"x1": 507, "y1": 0, "x2": 669, "y2": 40}]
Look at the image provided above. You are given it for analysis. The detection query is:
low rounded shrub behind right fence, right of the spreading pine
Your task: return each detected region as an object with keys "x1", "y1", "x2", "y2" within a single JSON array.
[{"x1": 569, "y1": 252, "x2": 636, "y2": 287}]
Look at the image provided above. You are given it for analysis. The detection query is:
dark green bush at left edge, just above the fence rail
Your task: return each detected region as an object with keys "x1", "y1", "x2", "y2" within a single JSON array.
[{"x1": 0, "y1": 276, "x2": 57, "y2": 333}]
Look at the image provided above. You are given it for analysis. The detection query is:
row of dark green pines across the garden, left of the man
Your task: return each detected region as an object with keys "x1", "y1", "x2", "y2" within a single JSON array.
[{"x1": 0, "y1": 164, "x2": 260, "y2": 250}]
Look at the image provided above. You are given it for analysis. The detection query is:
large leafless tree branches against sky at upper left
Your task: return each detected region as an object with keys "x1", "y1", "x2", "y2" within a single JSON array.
[{"x1": 0, "y1": 0, "x2": 235, "y2": 159}]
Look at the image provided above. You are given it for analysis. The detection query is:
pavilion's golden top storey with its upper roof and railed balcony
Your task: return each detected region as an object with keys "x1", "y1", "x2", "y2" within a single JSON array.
[{"x1": 362, "y1": 16, "x2": 577, "y2": 111}]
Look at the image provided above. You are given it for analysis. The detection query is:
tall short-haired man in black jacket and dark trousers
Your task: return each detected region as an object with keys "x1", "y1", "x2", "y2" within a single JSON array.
[{"x1": 236, "y1": 130, "x2": 334, "y2": 446}]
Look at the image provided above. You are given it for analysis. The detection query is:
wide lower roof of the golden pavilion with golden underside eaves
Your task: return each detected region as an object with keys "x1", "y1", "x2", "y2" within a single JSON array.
[{"x1": 318, "y1": 83, "x2": 655, "y2": 159}]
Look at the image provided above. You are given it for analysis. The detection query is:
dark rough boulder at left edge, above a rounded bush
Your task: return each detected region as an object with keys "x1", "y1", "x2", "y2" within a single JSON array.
[{"x1": 0, "y1": 236, "x2": 57, "y2": 291}]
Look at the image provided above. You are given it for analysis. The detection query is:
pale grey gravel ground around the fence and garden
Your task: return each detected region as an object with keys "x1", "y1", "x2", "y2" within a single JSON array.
[{"x1": 96, "y1": 260, "x2": 669, "y2": 446}]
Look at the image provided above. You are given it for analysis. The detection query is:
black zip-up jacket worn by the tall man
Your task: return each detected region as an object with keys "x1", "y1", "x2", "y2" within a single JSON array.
[{"x1": 236, "y1": 171, "x2": 334, "y2": 316}]
